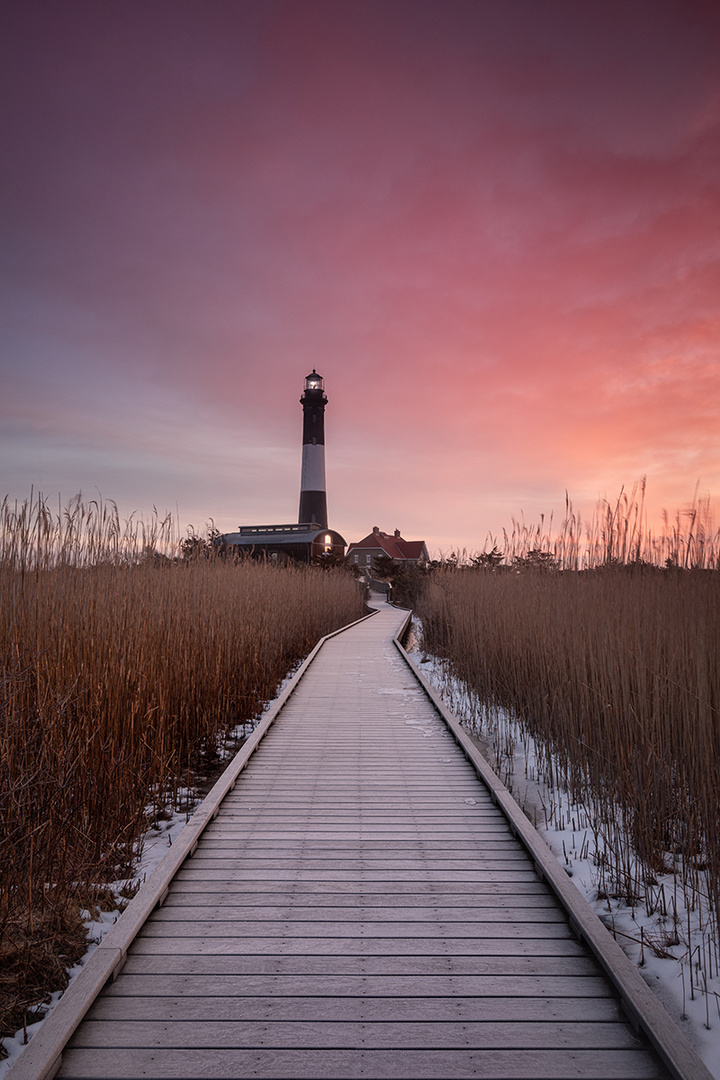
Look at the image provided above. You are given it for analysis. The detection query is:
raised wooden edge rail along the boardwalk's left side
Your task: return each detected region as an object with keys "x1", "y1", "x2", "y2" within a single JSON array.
[{"x1": 5, "y1": 611, "x2": 377, "y2": 1080}]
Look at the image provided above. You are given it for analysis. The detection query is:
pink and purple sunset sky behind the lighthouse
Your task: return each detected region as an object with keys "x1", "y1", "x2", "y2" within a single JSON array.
[{"x1": 0, "y1": 0, "x2": 720, "y2": 552}]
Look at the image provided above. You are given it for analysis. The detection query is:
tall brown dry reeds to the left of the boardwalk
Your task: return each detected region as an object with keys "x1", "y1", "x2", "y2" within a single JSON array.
[{"x1": 0, "y1": 498, "x2": 363, "y2": 1034}]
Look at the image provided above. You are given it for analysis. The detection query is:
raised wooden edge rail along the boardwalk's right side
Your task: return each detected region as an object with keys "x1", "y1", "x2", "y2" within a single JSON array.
[{"x1": 394, "y1": 611, "x2": 714, "y2": 1080}]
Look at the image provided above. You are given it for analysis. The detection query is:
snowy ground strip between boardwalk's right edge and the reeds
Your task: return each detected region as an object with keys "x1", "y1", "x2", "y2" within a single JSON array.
[{"x1": 409, "y1": 635, "x2": 720, "y2": 1080}]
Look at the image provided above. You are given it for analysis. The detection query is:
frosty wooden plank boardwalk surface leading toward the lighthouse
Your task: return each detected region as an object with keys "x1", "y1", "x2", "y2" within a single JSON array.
[{"x1": 11, "y1": 605, "x2": 709, "y2": 1080}]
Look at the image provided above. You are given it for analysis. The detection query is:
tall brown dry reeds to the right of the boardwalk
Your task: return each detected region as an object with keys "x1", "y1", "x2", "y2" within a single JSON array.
[{"x1": 417, "y1": 496, "x2": 720, "y2": 989}]
